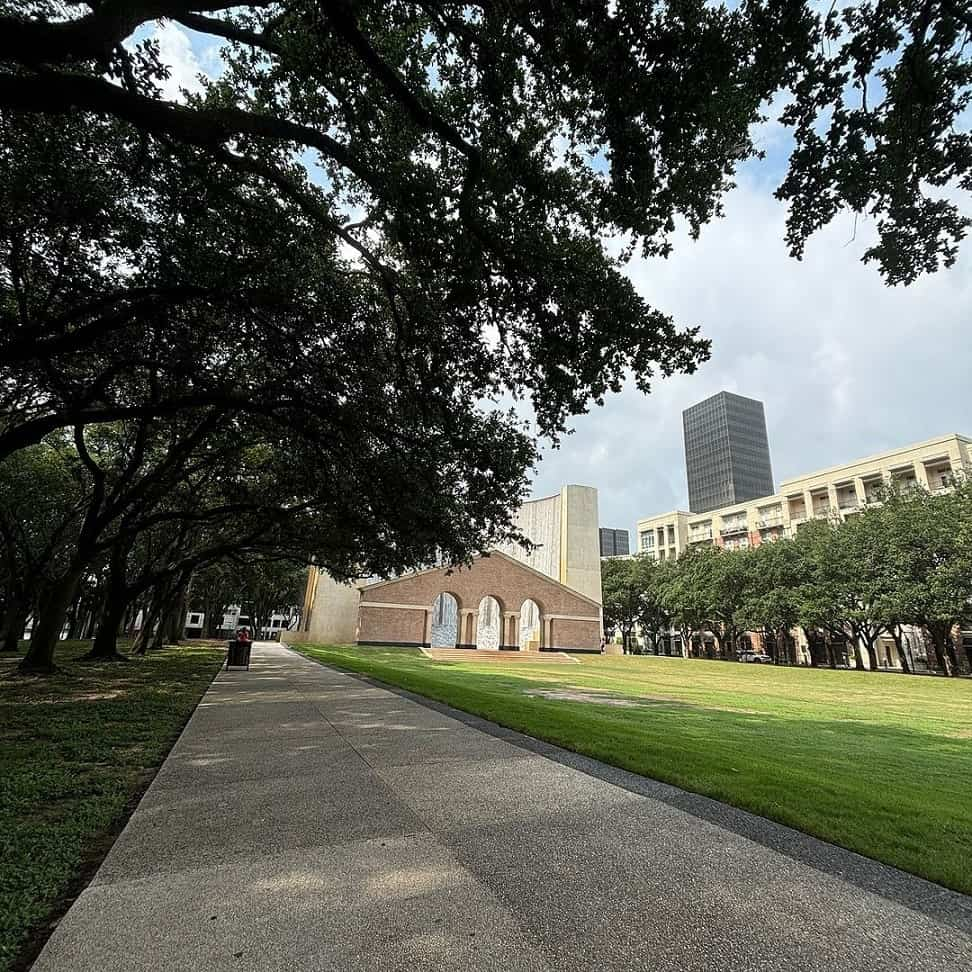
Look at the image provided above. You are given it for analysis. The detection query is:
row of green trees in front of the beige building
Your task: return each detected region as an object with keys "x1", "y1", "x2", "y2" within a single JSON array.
[{"x1": 602, "y1": 482, "x2": 972, "y2": 675}]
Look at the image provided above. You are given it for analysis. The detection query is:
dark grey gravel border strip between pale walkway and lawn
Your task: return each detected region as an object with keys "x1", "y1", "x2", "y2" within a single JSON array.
[{"x1": 286, "y1": 646, "x2": 972, "y2": 935}]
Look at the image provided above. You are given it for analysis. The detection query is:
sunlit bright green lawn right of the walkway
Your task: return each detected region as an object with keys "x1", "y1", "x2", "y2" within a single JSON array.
[{"x1": 300, "y1": 646, "x2": 972, "y2": 893}]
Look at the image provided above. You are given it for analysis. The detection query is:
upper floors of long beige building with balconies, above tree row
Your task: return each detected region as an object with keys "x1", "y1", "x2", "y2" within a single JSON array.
[{"x1": 637, "y1": 433, "x2": 972, "y2": 560}]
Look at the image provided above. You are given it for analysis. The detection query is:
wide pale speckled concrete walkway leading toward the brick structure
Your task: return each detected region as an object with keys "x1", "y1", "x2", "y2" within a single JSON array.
[{"x1": 34, "y1": 645, "x2": 972, "y2": 972}]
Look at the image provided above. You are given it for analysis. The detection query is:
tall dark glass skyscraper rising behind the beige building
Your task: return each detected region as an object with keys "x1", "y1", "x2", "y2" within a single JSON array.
[{"x1": 682, "y1": 392, "x2": 773, "y2": 513}]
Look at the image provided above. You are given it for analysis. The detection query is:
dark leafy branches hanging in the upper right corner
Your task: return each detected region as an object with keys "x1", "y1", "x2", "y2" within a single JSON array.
[{"x1": 777, "y1": 0, "x2": 972, "y2": 284}]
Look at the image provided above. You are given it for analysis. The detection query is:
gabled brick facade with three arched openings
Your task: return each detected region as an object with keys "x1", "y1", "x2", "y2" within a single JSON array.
[{"x1": 357, "y1": 551, "x2": 601, "y2": 651}]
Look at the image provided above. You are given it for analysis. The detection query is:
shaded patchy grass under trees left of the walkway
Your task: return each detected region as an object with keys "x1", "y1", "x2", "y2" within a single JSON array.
[{"x1": 0, "y1": 642, "x2": 224, "y2": 970}]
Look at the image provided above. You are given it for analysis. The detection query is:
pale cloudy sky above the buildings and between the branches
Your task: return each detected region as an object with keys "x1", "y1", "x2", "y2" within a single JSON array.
[{"x1": 156, "y1": 24, "x2": 972, "y2": 543}]
